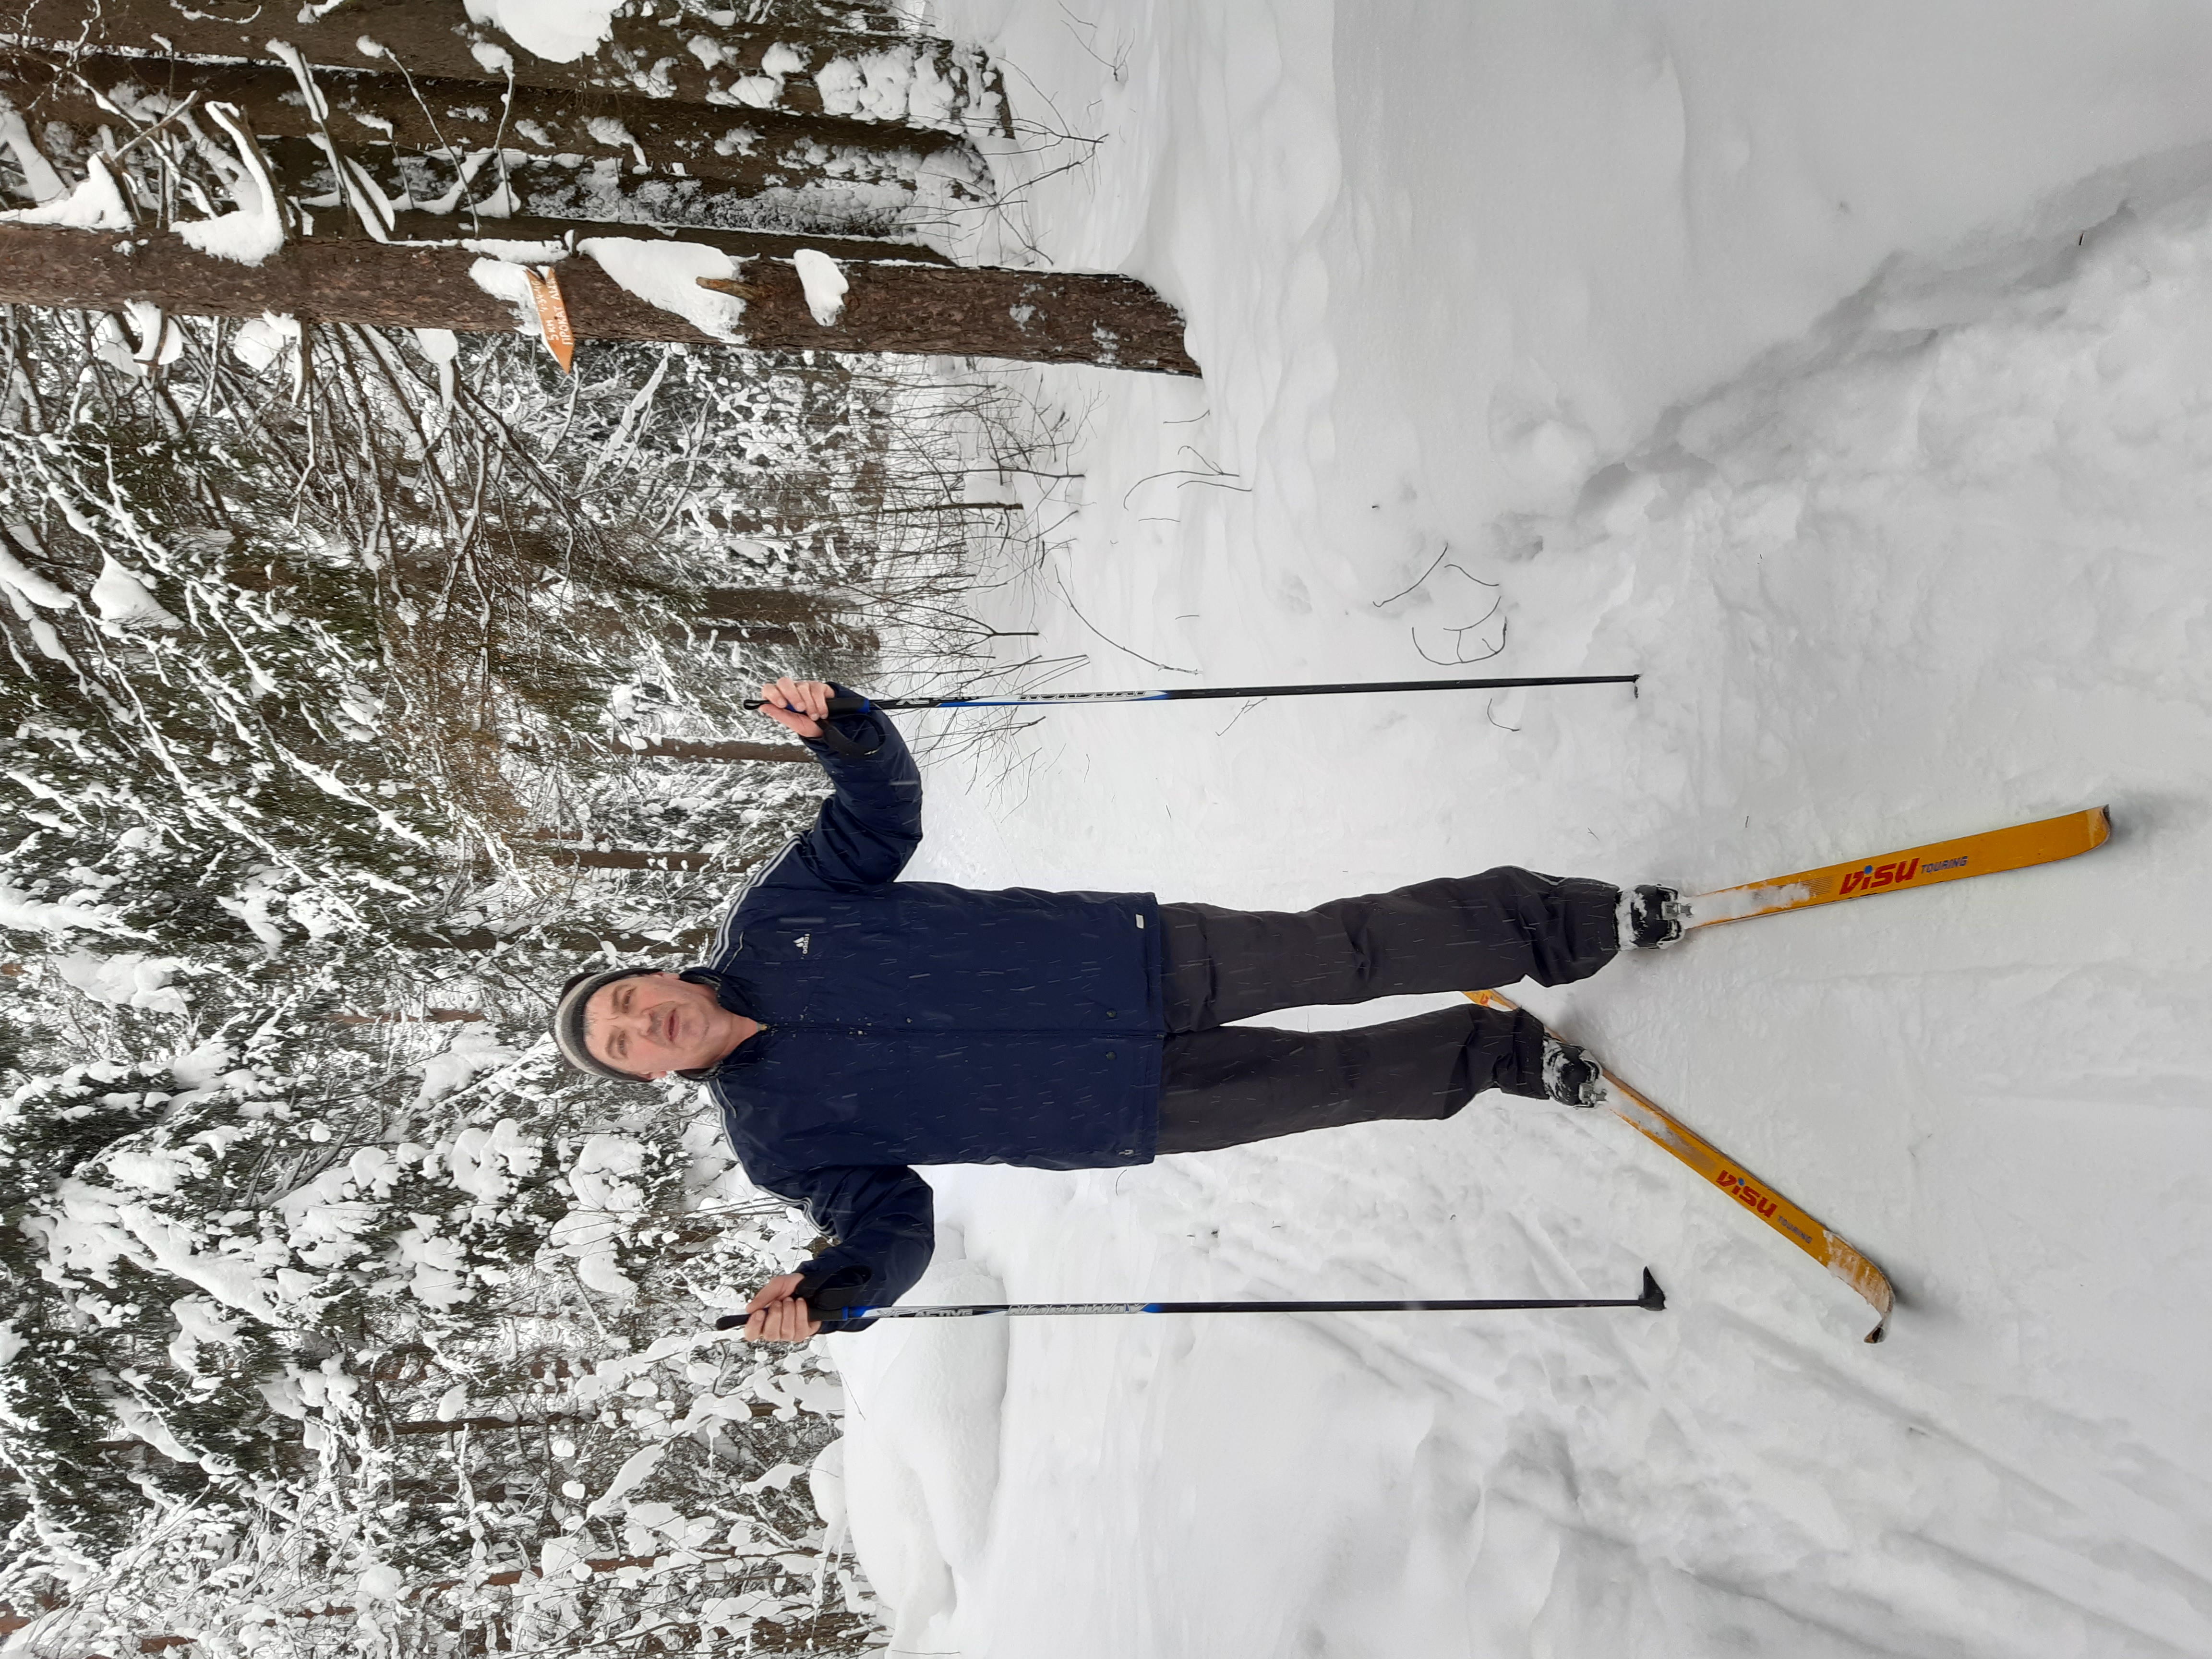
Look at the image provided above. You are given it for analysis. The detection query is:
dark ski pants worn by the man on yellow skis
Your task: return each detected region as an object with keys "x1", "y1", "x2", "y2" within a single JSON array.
[{"x1": 1159, "y1": 867, "x2": 1619, "y2": 1153}]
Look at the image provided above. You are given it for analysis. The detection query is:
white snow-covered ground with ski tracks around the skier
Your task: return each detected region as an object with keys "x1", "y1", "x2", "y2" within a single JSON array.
[{"x1": 832, "y1": 0, "x2": 2212, "y2": 1659}]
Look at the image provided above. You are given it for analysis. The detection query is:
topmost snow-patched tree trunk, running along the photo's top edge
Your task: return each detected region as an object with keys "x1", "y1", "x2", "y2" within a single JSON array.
[{"x1": 11, "y1": 0, "x2": 1002, "y2": 126}]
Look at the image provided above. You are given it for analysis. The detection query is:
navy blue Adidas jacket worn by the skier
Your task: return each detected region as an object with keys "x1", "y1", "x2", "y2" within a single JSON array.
[{"x1": 685, "y1": 712, "x2": 1166, "y2": 1314}]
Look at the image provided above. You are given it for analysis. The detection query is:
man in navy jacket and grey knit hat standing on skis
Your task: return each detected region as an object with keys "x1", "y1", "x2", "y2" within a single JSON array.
[{"x1": 553, "y1": 679, "x2": 1679, "y2": 1343}]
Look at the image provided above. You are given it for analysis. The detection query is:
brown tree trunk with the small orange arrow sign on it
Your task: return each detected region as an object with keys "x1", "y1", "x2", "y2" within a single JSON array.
[{"x1": 0, "y1": 226, "x2": 1199, "y2": 374}]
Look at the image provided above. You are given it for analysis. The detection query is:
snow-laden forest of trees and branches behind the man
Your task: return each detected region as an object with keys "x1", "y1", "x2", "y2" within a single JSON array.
[{"x1": 0, "y1": 0, "x2": 1126, "y2": 1659}]
